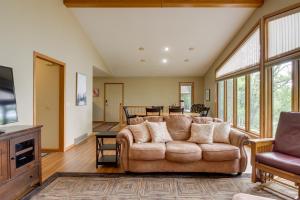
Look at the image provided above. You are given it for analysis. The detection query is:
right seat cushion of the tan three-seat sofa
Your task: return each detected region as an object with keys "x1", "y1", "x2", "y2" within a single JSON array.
[{"x1": 200, "y1": 143, "x2": 241, "y2": 162}]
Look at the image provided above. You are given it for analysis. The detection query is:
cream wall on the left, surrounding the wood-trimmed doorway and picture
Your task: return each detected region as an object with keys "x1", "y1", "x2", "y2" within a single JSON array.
[{"x1": 0, "y1": 0, "x2": 107, "y2": 146}]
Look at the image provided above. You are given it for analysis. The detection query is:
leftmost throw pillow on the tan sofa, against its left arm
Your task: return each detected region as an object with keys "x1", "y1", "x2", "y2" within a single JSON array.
[{"x1": 128, "y1": 122, "x2": 151, "y2": 143}]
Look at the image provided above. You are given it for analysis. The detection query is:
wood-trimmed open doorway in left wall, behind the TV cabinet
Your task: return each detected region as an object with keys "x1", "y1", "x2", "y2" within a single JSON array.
[{"x1": 33, "y1": 52, "x2": 65, "y2": 152}]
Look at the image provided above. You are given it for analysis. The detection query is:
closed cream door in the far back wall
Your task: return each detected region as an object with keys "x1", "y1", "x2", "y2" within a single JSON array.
[{"x1": 105, "y1": 83, "x2": 123, "y2": 122}]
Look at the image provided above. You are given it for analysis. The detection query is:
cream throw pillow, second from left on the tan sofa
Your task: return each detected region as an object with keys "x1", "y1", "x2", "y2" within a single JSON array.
[{"x1": 146, "y1": 121, "x2": 172, "y2": 143}]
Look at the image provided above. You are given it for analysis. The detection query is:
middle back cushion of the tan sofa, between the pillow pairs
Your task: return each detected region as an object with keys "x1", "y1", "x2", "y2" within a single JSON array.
[{"x1": 164, "y1": 115, "x2": 192, "y2": 140}]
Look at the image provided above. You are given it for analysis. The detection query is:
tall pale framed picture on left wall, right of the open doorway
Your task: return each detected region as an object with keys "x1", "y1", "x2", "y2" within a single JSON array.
[{"x1": 76, "y1": 72, "x2": 87, "y2": 106}]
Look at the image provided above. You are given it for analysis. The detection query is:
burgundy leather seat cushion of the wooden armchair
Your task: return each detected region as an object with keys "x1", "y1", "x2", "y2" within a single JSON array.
[{"x1": 256, "y1": 152, "x2": 300, "y2": 175}]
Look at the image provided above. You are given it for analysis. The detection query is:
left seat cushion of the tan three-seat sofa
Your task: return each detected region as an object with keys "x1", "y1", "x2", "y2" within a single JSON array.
[{"x1": 129, "y1": 143, "x2": 166, "y2": 160}]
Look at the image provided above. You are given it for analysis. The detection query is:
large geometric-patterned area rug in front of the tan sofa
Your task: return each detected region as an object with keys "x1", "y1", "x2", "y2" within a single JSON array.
[{"x1": 25, "y1": 173, "x2": 296, "y2": 200}]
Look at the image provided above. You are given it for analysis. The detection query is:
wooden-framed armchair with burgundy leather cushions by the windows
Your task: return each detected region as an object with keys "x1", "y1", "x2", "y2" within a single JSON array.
[{"x1": 250, "y1": 112, "x2": 300, "y2": 199}]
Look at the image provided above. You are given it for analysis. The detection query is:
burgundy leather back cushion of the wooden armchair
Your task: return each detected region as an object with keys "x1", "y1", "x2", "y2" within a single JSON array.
[{"x1": 274, "y1": 112, "x2": 300, "y2": 158}]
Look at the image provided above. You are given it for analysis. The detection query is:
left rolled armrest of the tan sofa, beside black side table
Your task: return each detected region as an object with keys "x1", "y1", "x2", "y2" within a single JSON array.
[{"x1": 117, "y1": 127, "x2": 133, "y2": 171}]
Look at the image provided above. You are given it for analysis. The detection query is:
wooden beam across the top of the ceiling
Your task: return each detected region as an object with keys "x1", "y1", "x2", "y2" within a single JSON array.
[{"x1": 64, "y1": 0, "x2": 264, "y2": 8}]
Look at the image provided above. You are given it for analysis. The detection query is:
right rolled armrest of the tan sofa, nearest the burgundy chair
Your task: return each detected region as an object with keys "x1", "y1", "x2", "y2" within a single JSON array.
[{"x1": 229, "y1": 129, "x2": 249, "y2": 173}]
